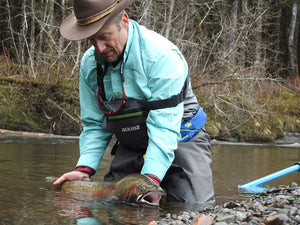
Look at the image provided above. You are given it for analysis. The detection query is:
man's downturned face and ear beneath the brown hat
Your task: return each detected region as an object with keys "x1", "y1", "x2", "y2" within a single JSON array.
[{"x1": 89, "y1": 13, "x2": 129, "y2": 63}]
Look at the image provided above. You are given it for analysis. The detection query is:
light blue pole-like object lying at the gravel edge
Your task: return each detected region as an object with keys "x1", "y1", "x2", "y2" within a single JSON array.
[{"x1": 238, "y1": 162, "x2": 300, "y2": 193}]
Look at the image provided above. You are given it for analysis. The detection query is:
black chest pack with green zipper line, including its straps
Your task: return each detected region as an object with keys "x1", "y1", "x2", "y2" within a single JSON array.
[{"x1": 97, "y1": 62, "x2": 188, "y2": 151}]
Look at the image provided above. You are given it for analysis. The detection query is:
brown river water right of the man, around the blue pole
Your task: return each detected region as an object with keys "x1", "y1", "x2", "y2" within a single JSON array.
[{"x1": 212, "y1": 143, "x2": 300, "y2": 201}]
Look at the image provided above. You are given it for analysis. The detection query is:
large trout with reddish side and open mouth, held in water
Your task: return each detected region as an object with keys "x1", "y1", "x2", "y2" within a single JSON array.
[{"x1": 46, "y1": 173, "x2": 165, "y2": 206}]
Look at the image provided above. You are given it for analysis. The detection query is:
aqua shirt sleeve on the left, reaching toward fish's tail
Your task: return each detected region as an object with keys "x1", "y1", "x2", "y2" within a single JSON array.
[{"x1": 76, "y1": 53, "x2": 112, "y2": 171}]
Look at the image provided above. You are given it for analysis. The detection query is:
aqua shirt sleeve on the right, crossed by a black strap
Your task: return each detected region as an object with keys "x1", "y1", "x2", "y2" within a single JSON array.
[{"x1": 141, "y1": 50, "x2": 188, "y2": 180}]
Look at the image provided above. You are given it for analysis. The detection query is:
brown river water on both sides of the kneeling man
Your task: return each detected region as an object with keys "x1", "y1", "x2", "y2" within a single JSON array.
[{"x1": 0, "y1": 135, "x2": 300, "y2": 225}]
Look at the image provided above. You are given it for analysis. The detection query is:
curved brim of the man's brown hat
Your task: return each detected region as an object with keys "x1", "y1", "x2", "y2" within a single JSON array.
[{"x1": 60, "y1": 0, "x2": 135, "y2": 41}]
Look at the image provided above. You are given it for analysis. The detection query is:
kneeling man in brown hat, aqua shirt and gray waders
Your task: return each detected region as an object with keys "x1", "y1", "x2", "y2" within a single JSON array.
[{"x1": 54, "y1": 0, "x2": 214, "y2": 203}]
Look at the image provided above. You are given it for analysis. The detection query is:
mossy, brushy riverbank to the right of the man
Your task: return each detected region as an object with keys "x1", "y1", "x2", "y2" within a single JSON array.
[{"x1": 202, "y1": 88, "x2": 300, "y2": 143}]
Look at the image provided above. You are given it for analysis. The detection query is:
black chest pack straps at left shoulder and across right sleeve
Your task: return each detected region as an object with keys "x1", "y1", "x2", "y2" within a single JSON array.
[{"x1": 97, "y1": 63, "x2": 189, "y2": 110}]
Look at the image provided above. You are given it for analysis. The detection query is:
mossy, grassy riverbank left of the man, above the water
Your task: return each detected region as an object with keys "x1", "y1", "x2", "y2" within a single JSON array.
[{"x1": 0, "y1": 77, "x2": 81, "y2": 135}]
